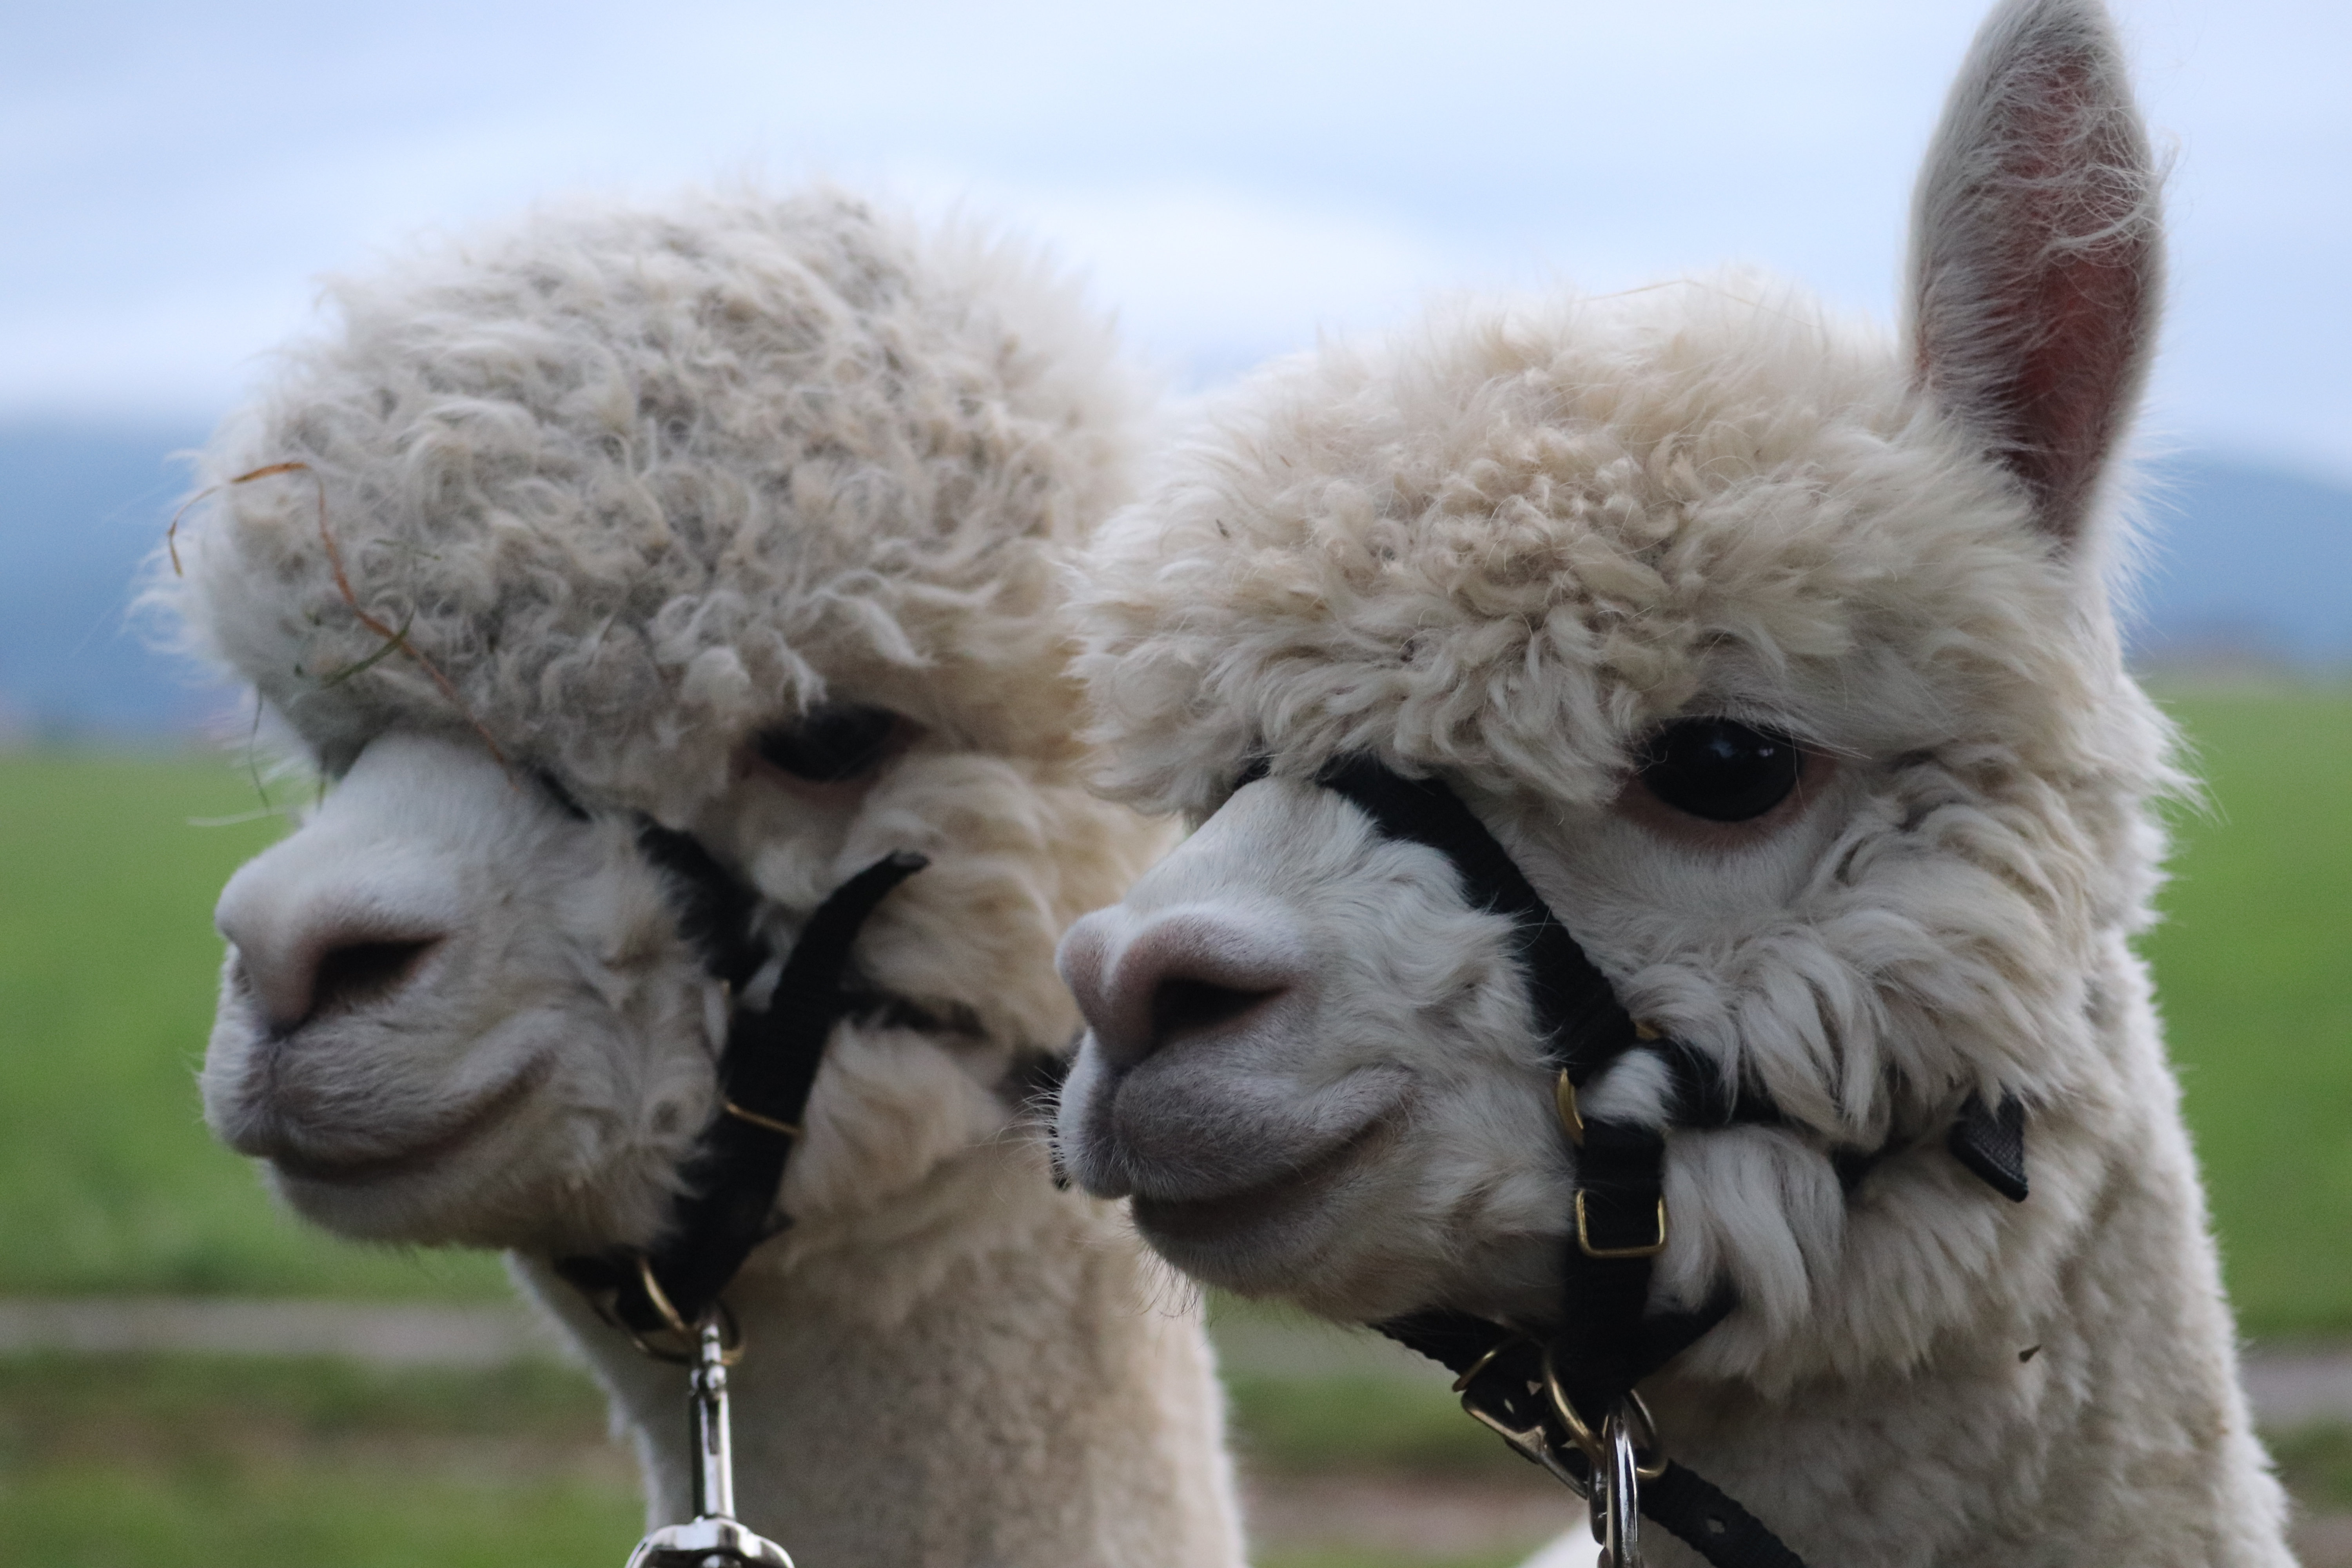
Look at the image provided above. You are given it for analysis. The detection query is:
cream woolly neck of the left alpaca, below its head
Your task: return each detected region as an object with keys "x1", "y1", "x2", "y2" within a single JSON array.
[{"x1": 515, "y1": 1140, "x2": 1242, "y2": 1568}]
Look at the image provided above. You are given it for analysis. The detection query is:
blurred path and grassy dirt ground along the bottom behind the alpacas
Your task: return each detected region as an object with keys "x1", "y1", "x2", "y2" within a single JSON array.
[{"x1": 0, "y1": 1302, "x2": 2352, "y2": 1568}]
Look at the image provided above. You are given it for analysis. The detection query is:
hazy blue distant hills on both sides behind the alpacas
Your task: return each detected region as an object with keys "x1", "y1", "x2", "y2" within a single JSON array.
[{"x1": 0, "y1": 423, "x2": 2352, "y2": 738}]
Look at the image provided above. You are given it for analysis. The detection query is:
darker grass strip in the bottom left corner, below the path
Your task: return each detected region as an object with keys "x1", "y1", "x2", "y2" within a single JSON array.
[{"x1": 0, "y1": 1356, "x2": 642, "y2": 1568}]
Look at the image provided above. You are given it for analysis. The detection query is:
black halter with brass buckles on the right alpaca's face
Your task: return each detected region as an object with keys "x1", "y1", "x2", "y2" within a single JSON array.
[{"x1": 1235, "y1": 757, "x2": 2025, "y2": 1568}]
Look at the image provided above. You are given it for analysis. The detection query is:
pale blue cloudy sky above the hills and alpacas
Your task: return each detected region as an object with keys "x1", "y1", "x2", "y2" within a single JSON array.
[{"x1": 14, "y1": 0, "x2": 2352, "y2": 479}]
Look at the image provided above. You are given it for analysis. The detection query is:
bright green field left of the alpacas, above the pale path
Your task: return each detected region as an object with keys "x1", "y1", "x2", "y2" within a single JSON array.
[{"x1": 0, "y1": 752, "x2": 506, "y2": 1298}]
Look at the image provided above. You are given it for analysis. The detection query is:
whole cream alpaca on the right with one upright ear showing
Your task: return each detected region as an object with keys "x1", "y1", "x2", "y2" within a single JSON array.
[{"x1": 1058, "y1": 0, "x2": 2288, "y2": 1568}]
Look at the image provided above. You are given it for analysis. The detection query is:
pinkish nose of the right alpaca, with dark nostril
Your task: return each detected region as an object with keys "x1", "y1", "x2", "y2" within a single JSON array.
[{"x1": 1058, "y1": 907, "x2": 1305, "y2": 1067}]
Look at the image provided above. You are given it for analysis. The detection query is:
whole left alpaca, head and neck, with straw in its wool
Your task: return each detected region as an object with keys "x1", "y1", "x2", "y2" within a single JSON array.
[{"x1": 165, "y1": 191, "x2": 1240, "y2": 1568}]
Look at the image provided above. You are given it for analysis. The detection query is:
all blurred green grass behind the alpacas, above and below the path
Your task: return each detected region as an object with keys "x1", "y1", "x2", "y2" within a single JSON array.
[{"x1": 0, "y1": 689, "x2": 2352, "y2": 1568}]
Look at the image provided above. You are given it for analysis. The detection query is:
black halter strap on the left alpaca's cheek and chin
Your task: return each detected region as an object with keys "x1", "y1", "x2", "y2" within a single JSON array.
[{"x1": 555, "y1": 822, "x2": 929, "y2": 1345}]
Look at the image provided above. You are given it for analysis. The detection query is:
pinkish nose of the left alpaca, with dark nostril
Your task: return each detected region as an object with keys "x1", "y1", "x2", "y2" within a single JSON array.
[{"x1": 216, "y1": 886, "x2": 445, "y2": 1034}]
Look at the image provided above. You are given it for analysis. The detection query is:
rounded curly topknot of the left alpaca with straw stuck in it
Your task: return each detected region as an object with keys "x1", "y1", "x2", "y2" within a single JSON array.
[{"x1": 162, "y1": 191, "x2": 1141, "y2": 818}]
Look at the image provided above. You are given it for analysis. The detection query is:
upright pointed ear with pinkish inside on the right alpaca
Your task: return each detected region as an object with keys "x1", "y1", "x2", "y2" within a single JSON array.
[{"x1": 1910, "y1": 0, "x2": 2164, "y2": 543}]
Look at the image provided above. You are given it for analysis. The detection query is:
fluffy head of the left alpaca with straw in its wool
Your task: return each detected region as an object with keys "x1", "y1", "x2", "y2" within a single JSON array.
[{"x1": 167, "y1": 193, "x2": 1152, "y2": 1250}]
